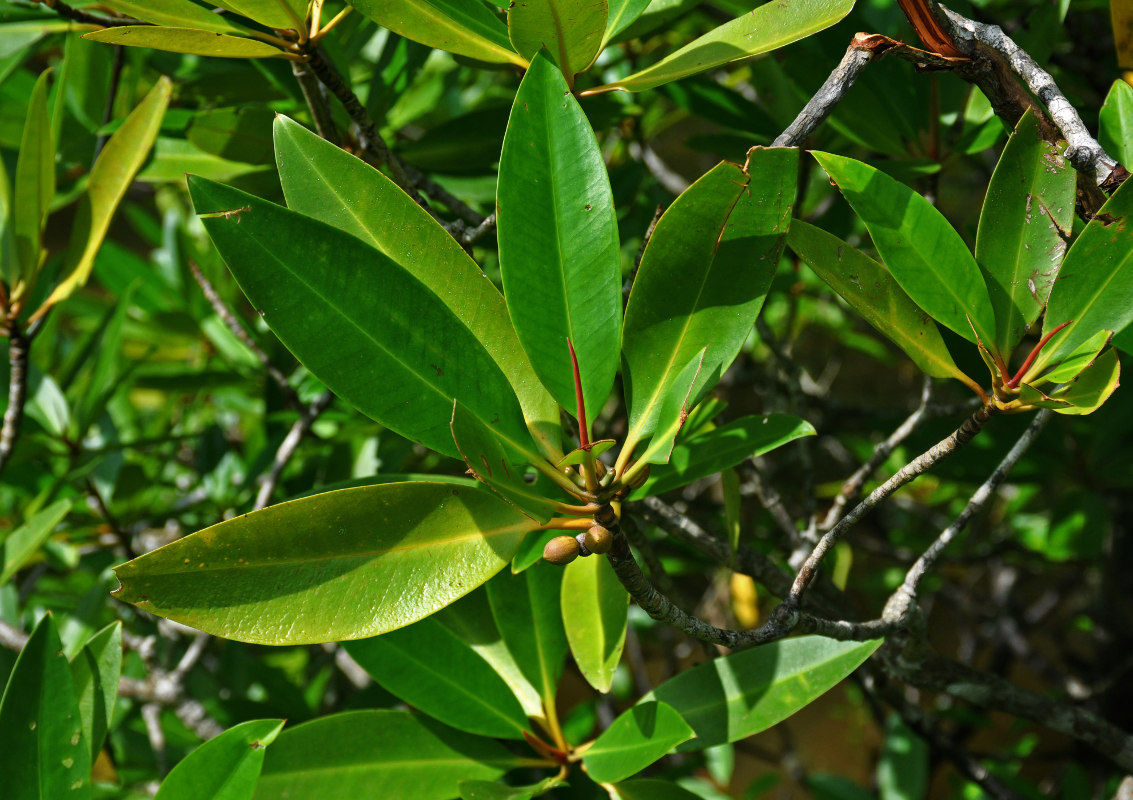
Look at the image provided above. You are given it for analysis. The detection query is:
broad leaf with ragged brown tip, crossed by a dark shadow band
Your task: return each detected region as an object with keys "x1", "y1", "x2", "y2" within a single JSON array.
[{"x1": 622, "y1": 147, "x2": 799, "y2": 455}]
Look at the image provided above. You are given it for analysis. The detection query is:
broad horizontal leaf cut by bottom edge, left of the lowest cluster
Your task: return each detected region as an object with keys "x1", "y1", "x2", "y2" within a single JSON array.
[{"x1": 255, "y1": 709, "x2": 525, "y2": 800}]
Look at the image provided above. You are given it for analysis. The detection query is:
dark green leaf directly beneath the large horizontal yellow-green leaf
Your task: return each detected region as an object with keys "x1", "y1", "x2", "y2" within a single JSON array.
[{"x1": 346, "y1": 618, "x2": 530, "y2": 739}]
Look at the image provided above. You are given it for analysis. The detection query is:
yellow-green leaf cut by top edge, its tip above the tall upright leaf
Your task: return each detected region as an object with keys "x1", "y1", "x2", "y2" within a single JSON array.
[{"x1": 350, "y1": 0, "x2": 527, "y2": 67}]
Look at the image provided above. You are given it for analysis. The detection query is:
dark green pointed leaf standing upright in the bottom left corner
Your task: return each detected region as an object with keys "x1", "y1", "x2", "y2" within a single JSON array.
[{"x1": 0, "y1": 613, "x2": 91, "y2": 800}]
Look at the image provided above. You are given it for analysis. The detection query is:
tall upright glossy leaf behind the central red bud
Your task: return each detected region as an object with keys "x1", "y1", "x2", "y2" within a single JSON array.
[{"x1": 496, "y1": 56, "x2": 622, "y2": 419}]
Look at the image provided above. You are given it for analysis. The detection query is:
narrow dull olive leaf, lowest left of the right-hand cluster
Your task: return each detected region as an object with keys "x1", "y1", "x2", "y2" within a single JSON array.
[{"x1": 786, "y1": 220, "x2": 970, "y2": 383}]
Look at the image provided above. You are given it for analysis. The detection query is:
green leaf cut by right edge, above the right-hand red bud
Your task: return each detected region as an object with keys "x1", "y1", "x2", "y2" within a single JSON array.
[{"x1": 1034, "y1": 175, "x2": 1133, "y2": 368}]
